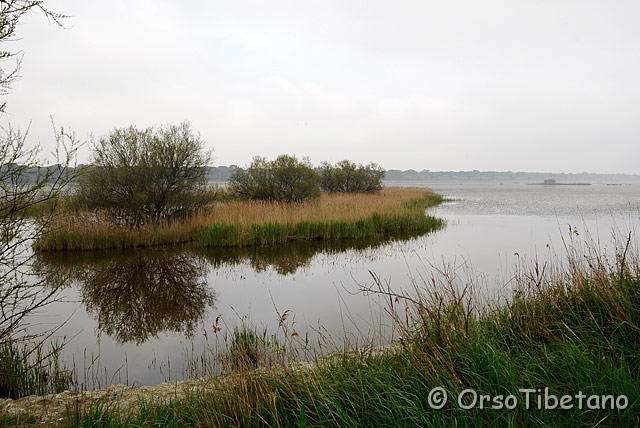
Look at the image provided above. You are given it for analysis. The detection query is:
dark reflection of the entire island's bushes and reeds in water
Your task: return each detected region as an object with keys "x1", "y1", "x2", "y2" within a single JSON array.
[{"x1": 33, "y1": 231, "x2": 436, "y2": 344}]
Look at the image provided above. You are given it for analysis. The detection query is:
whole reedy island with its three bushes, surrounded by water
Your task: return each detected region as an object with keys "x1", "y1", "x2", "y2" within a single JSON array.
[{"x1": 34, "y1": 140, "x2": 443, "y2": 251}]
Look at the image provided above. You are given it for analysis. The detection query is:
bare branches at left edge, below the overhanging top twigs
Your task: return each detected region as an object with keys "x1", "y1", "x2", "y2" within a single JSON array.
[{"x1": 0, "y1": 123, "x2": 79, "y2": 345}]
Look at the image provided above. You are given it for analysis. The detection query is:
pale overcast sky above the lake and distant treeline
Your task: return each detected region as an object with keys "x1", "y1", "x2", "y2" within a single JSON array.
[{"x1": 5, "y1": 0, "x2": 640, "y2": 174}]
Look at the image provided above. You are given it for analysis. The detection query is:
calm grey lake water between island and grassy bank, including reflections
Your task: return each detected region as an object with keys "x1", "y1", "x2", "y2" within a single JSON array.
[{"x1": 23, "y1": 177, "x2": 640, "y2": 388}]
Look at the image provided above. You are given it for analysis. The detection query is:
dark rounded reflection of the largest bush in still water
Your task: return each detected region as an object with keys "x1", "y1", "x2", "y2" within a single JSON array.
[{"x1": 40, "y1": 249, "x2": 216, "y2": 344}]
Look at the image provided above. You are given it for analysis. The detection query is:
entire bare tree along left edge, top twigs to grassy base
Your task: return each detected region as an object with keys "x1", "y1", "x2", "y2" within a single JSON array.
[{"x1": 0, "y1": 0, "x2": 85, "y2": 397}]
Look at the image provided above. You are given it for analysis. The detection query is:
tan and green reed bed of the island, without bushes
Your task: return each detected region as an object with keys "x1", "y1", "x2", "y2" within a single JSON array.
[{"x1": 35, "y1": 187, "x2": 442, "y2": 251}]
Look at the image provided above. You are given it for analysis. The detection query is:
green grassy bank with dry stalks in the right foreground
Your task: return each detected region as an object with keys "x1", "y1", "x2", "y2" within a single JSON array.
[{"x1": 40, "y1": 229, "x2": 640, "y2": 427}]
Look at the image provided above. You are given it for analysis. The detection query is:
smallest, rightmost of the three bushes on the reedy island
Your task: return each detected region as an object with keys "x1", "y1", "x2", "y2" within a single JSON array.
[{"x1": 319, "y1": 160, "x2": 385, "y2": 193}]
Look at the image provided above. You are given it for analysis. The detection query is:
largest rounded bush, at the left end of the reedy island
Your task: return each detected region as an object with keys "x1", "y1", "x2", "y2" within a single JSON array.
[{"x1": 77, "y1": 122, "x2": 211, "y2": 227}]
